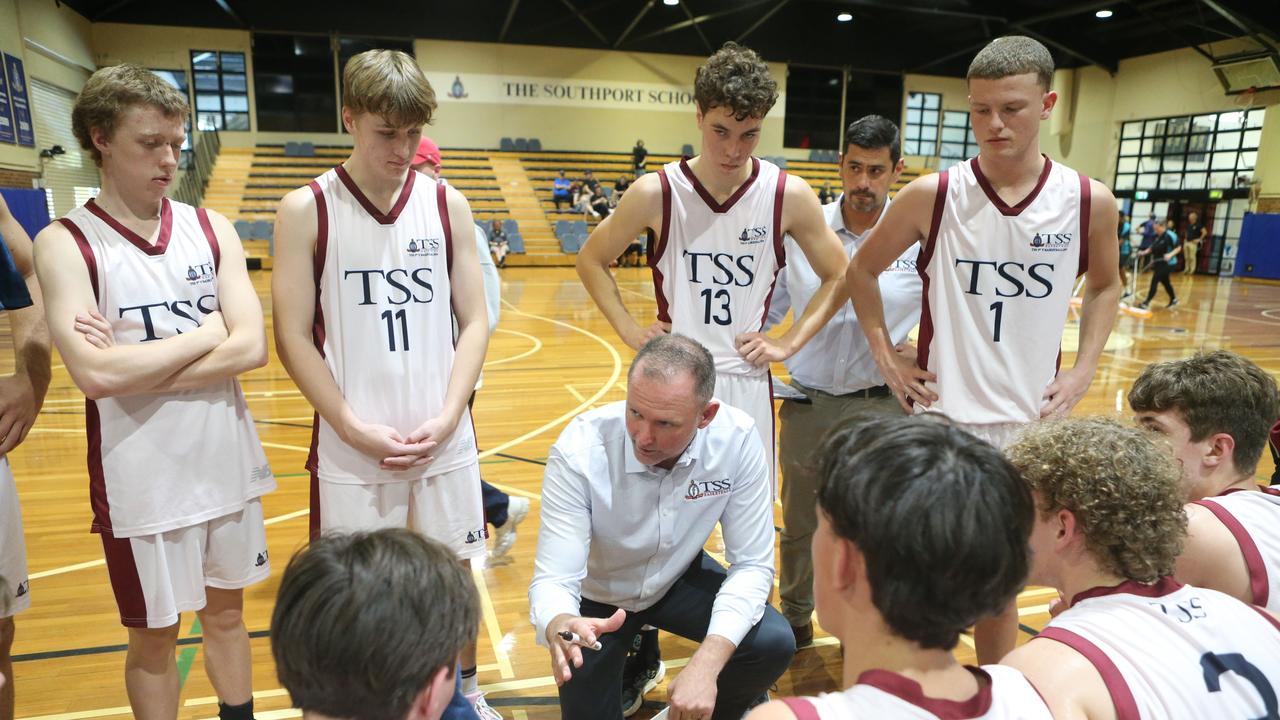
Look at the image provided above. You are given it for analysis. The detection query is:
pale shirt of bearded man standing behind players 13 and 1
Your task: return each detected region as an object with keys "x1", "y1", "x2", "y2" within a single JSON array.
[{"x1": 767, "y1": 195, "x2": 924, "y2": 395}]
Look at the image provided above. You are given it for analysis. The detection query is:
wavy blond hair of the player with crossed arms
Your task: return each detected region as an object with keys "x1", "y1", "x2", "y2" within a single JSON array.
[{"x1": 72, "y1": 63, "x2": 191, "y2": 168}]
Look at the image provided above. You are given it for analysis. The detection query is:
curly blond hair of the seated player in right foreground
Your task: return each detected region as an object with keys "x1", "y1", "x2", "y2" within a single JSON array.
[{"x1": 1006, "y1": 418, "x2": 1187, "y2": 583}]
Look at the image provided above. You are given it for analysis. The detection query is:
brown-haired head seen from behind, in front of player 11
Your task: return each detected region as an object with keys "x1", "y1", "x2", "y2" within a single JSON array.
[{"x1": 271, "y1": 528, "x2": 480, "y2": 720}]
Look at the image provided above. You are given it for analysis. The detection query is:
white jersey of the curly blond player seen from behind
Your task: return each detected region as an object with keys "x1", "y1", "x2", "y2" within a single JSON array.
[{"x1": 1032, "y1": 578, "x2": 1280, "y2": 720}]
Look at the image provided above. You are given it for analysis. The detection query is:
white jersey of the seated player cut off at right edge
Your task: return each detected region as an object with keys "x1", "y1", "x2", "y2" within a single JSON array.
[{"x1": 1197, "y1": 488, "x2": 1280, "y2": 612}]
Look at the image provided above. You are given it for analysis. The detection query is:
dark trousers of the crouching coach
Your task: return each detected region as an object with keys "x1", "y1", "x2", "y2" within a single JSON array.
[{"x1": 559, "y1": 552, "x2": 796, "y2": 720}]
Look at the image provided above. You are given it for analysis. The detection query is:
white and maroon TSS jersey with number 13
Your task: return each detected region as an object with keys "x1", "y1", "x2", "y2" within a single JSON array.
[{"x1": 649, "y1": 158, "x2": 786, "y2": 375}]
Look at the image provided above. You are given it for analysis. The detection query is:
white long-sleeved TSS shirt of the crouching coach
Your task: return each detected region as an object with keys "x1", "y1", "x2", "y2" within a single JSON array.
[{"x1": 529, "y1": 401, "x2": 773, "y2": 644}]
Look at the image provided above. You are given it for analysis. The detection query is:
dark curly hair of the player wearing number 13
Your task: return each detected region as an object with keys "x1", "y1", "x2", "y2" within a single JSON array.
[{"x1": 694, "y1": 41, "x2": 778, "y2": 122}]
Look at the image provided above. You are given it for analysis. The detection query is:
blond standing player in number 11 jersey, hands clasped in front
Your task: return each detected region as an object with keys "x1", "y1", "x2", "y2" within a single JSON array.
[{"x1": 271, "y1": 50, "x2": 497, "y2": 716}]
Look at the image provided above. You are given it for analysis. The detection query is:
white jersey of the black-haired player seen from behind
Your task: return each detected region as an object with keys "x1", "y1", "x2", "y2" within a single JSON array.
[{"x1": 785, "y1": 665, "x2": 1053, "y2": 720}]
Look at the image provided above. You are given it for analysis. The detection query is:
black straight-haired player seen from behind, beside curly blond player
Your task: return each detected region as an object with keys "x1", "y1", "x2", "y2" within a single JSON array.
[{"x1": 750, "y1": 416, "x2": 1051, "y2": 720}]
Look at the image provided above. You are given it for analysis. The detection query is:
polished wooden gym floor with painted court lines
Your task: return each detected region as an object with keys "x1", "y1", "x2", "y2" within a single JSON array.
[{"x1": 0, "y1": 268, "x2": 1280, "y2": 720}]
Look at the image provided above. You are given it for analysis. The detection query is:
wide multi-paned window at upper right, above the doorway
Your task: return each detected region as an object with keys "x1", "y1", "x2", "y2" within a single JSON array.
[{"x1": 1115, "y1": 108, "x2": 1263, "y2": 191}]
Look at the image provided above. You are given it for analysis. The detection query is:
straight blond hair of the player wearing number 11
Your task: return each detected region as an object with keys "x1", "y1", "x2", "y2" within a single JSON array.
[{"x1": 342, "y1": 50, "x2": 436, "y2": 127}]
